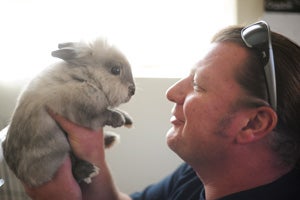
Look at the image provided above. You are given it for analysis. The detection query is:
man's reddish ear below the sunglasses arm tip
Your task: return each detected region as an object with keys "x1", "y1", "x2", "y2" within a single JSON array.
[{"x1": 236, "y1": 106, "x2": 278, "y2": 144}]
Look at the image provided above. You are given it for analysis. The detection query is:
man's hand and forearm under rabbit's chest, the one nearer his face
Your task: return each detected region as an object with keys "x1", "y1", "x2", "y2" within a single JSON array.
[{"x1": 48, "y1": 110, "x2": 125, "y2": 200}]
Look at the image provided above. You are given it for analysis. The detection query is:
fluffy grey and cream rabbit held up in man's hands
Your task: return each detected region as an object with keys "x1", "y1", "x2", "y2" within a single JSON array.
[{"x1": 3, "y1": 38, "x2": 135, "y2": 186}]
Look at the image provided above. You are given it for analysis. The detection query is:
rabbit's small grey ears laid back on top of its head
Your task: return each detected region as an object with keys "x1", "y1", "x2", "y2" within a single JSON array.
[{"x1": 51, "y1": 42, "x2": 91, "y2": 61}]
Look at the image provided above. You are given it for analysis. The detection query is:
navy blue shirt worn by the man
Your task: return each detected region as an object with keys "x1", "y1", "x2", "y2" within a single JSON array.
[{"x1": 131, "y1": 164, "x2": 300, "y2": 200}]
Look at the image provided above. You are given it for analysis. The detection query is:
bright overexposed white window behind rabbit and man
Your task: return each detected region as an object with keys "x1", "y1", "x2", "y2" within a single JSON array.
[{"x1": 0, "y1": 0, "x2": 236, "y2": 80}]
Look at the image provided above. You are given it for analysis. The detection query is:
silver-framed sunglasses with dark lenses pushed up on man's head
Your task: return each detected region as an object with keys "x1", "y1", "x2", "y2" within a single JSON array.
[{"x1": 241, "y1": 21, "x2": 277, "y2": 111}]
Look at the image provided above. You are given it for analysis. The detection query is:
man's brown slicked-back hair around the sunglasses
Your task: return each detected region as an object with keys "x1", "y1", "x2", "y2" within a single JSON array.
[{"x1": 212, "y1": 26, "x2": 300, "y2": 165}]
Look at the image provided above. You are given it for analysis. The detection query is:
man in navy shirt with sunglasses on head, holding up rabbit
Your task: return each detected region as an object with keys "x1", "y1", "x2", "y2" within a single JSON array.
[{"x1": 26, "y1": 22, "x2": 300, "y2": 200}]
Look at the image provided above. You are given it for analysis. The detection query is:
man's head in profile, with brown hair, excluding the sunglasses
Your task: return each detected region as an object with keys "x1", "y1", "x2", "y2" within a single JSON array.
[{"x1": 167, "y1": 21, "x2": 300, "y2": 169}]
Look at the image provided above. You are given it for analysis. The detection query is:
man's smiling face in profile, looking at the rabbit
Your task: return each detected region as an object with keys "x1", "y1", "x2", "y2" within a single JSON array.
[{"x1": 167, "y1": 43, "x2": 246, "y2": 165}]
